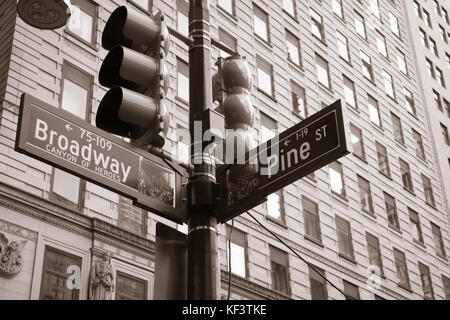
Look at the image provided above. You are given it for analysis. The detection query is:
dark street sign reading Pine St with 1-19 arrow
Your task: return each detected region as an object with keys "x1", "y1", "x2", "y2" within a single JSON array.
[{"x1": 217, "y1": 100, "x2": 349, "y2": 223}]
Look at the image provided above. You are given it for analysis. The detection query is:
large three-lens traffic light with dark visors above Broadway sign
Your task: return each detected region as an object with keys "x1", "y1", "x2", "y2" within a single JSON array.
[{"x1": 96, "y1": 6, "x2": 169, "y2": 148}]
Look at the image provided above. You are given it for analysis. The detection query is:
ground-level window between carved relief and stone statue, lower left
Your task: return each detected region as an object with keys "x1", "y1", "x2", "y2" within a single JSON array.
[{"x1": 39, "y1": 246, "x2": 82, "y2": 300}]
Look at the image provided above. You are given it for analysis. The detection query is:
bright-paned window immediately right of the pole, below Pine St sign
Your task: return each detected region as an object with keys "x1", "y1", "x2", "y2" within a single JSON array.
[{"x1": 226, "y1": 225, "x2": 247, "y2": 278}]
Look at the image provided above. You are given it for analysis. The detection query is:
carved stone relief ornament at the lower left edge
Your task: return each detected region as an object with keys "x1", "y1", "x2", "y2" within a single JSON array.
[{"x1": 0, "y1": 233, "x2": 27, "y2": 278}]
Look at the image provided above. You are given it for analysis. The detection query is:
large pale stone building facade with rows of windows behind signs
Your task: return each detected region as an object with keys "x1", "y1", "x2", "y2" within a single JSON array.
[{"x1": 0, "y1": 0, "x2": 450, "y2": 299}]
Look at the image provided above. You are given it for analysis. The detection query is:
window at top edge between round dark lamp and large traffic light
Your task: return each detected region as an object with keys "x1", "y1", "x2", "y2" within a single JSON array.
[{"x1": 67, "y1": 0, "x2": 97, "y2": 44}]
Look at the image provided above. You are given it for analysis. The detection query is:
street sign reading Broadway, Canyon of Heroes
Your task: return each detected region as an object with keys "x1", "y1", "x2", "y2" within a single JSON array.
[{"x1": 15, "y1": 94, "x2": 187, "y2": 223}]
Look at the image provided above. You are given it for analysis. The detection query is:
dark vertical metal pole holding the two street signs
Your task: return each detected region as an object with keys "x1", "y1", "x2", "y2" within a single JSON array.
[{"x1": 187, "y1": 0, "x2": 220, "y2": 300}]
